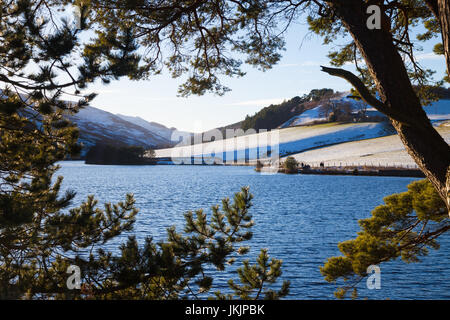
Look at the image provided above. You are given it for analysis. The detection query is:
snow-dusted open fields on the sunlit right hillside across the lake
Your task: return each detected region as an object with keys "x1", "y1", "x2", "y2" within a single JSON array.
[{"x1": 156, "y1": 94, "x2": 450, "y2": 164}]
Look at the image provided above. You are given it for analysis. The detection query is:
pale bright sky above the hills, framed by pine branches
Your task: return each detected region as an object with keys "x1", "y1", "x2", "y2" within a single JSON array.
[{"x1": 81, "y1": 24, "x2": 445, "y2": 132}]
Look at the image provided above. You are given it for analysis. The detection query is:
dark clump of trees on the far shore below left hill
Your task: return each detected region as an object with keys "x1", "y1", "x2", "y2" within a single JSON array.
[{"x1": 85, "y1": 144, "x2": 155, "y2": 165}]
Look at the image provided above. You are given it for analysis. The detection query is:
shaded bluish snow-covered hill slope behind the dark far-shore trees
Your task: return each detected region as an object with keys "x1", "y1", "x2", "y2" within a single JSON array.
[{"x1": 68, "y1": 106, "x2": 172, "y2": 155}]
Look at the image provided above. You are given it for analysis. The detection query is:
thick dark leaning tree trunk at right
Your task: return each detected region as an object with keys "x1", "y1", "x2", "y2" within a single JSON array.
[{"x1": 329, "y1": 0, "x2": 450, "y2": 208}]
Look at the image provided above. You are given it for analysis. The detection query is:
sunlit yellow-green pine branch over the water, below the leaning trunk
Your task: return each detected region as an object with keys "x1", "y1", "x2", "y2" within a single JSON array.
[{"x1": 320, "y1": 180, "x2": 450, "y2": 298}]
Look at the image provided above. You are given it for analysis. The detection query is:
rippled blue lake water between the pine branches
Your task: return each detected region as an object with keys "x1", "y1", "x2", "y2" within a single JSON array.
[{"x1": 57, "y1": 161, "x2": 450, "y2": 299}]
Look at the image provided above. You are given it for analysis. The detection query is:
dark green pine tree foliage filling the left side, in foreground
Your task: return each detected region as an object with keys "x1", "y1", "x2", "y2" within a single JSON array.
[{"x1": 0, "y1": 0, "x2": 287, "y2": 299}]
